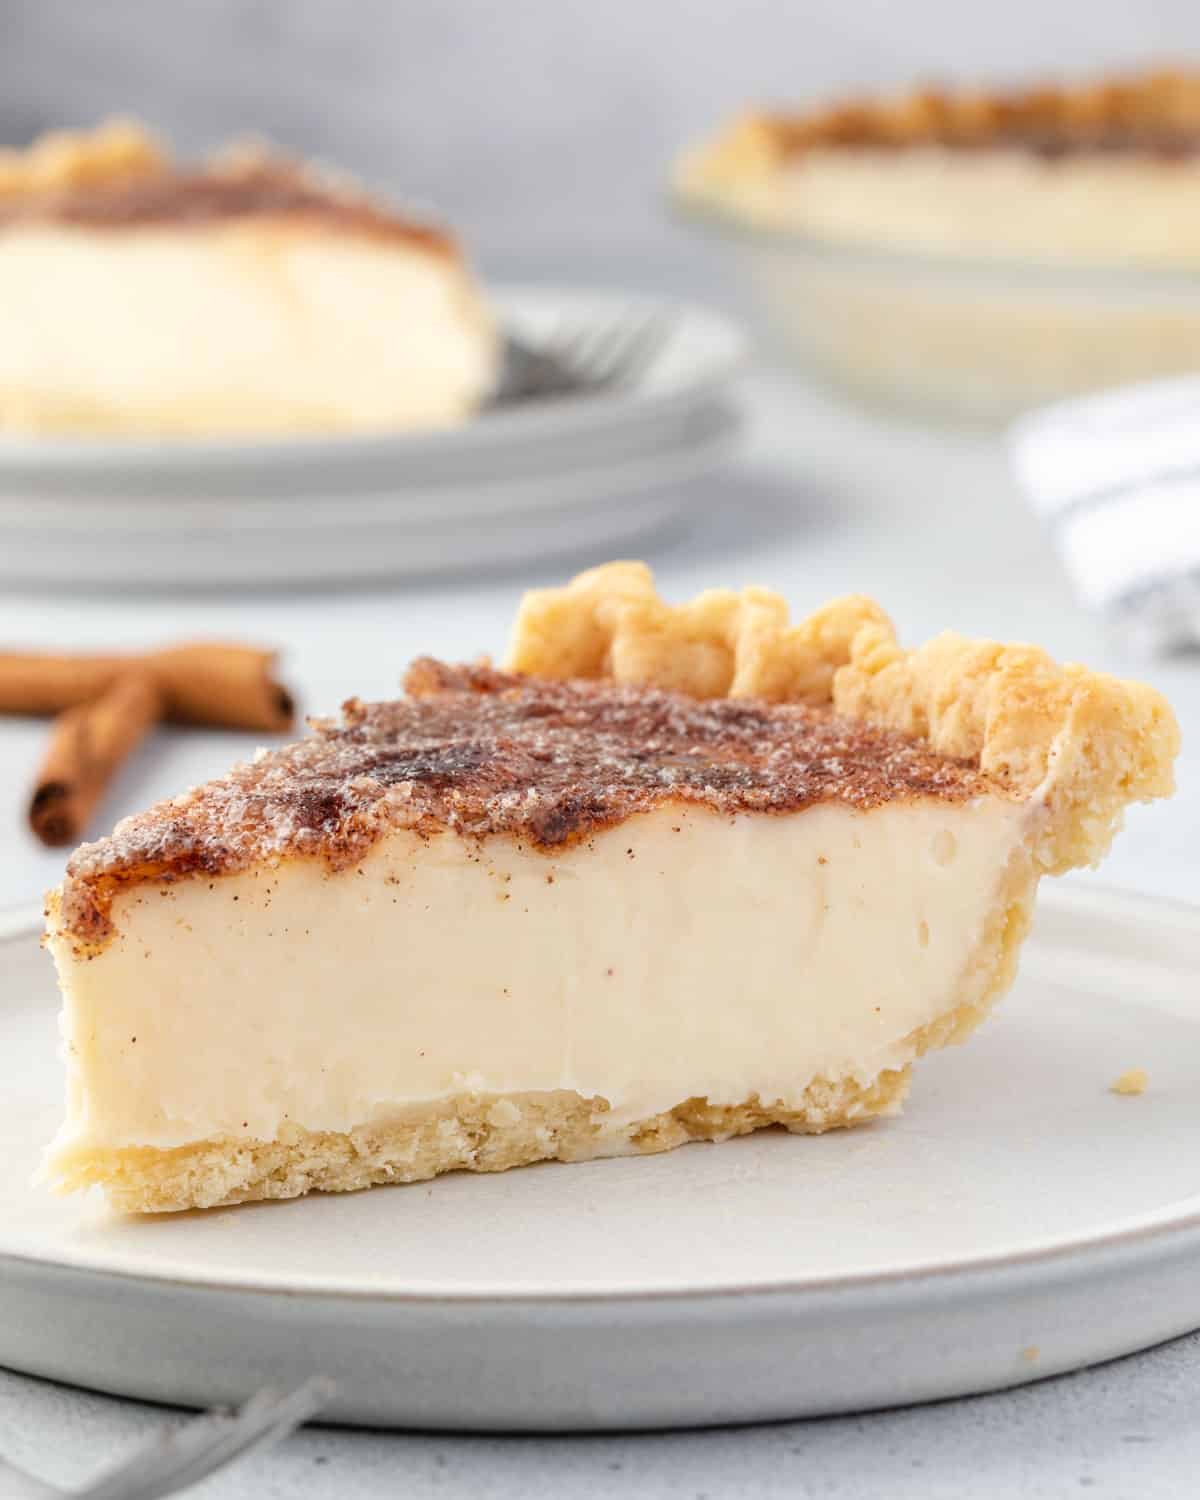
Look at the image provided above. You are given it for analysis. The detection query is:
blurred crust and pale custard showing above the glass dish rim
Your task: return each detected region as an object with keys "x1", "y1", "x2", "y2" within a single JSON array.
[{"x1": 675, "y1": 72, "x2": 1200, "y2": 267}]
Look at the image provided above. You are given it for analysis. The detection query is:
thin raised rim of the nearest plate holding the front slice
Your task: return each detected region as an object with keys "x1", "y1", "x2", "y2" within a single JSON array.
[{"x1": 9, "y1": 884, "x2": 1200, "y2": 1311}]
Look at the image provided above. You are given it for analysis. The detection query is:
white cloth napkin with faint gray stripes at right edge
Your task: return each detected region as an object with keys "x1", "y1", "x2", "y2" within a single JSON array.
[{"x1": 1010, "y1": 377, "x2": 1200, "y2": 651}]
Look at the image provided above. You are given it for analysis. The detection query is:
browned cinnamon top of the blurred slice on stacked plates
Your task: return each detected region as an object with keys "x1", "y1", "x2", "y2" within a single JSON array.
[{"x1": 0, "y1": 155, "x2": 456, "y2": 255}]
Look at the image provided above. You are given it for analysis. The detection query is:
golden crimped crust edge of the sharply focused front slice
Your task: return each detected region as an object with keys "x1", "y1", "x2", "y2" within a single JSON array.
[{"x1": 509, "y1": 563, "x2": 1179, "y2": 875}]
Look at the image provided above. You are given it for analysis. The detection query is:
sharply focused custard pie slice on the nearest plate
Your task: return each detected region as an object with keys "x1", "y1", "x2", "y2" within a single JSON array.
[{"x1": 45, "y1": 563, "x2": 1178, "y2": 1211}]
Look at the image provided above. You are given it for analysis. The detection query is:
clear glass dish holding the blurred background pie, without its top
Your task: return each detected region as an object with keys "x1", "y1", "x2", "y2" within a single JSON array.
[{"x1": 675, "y1": 201, "x2": 1200, "y2": 423}]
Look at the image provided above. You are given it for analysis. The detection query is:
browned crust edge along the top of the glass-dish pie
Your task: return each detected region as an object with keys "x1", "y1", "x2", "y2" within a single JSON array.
[{"x1": 678, "y1": 71, "x2": 1200, "y2": 194}]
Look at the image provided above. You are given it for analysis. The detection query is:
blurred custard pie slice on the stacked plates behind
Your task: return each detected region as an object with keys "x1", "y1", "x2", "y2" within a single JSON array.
[{"x1": 0, "y1": 123, "x2": 498, "y2": 438}]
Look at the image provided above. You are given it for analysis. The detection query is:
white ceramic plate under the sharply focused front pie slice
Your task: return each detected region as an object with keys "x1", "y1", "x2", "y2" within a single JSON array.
[{"x1": 0, "y1": 885, "x2": 1200, "y2": 1430}]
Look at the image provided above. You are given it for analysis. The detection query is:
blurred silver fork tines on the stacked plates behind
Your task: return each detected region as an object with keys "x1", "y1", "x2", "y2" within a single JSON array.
[{"x1": 492, "y1": 312, "x2": 674, "y2": 407}]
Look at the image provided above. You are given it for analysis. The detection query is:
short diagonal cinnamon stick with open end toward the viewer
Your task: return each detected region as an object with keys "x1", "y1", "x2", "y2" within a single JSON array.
[{"x1": 29, "y1": 672, "x2": 162, "y2": 848}]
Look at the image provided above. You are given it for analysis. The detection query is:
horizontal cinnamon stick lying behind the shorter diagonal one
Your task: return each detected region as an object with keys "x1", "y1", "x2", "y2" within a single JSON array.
[{"x1": 0, "y1": 642, "x2": 296, "y2": 734}]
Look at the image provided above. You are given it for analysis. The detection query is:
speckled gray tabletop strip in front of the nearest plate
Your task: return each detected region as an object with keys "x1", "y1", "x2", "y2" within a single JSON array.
[{"x1": 0, "y1": 1344, "x2": 1200, "y2": 1500}]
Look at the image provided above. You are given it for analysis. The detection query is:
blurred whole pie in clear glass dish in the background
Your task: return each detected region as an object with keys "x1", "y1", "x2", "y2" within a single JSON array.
[{"x1": 674, "y1": 72, "x2": 1200, "y2": 419}]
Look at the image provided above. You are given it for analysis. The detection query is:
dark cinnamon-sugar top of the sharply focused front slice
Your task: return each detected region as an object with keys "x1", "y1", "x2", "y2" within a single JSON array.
[{"x1": 62, "y1": 659, "x2": 998, "y2": 941}]
